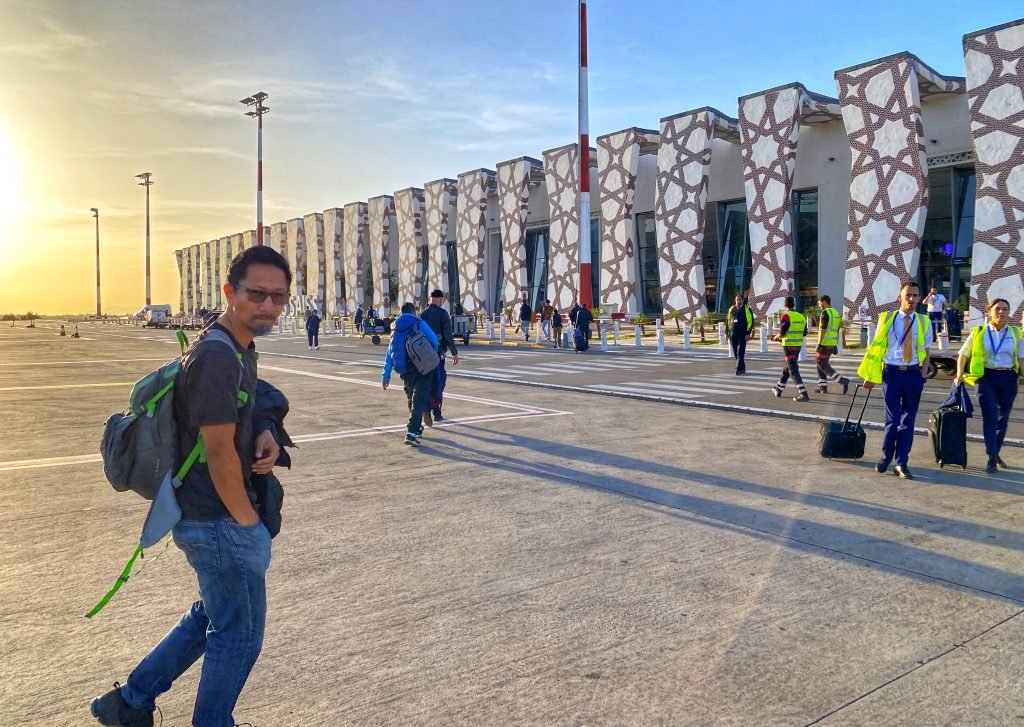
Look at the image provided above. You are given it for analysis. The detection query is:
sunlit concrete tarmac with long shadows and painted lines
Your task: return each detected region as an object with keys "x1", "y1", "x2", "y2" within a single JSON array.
[{"x1": 0, "y1": 322, "x2": 1024, "y2": 727}]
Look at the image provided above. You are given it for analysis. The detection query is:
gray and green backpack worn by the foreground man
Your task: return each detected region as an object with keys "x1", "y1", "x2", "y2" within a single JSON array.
[{"x1": 99, "y1": 328, "x2": 245, "y2": 500}]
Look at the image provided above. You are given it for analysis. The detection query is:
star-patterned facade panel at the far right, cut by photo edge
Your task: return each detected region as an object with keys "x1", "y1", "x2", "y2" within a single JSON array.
[{"x1": 964, "y1": 20, "x2": 1024, "y2": 323}]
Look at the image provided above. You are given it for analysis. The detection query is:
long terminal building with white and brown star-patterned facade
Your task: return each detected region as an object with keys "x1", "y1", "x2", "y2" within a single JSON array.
[{"x1": 175, "y1": 19, "x2": 1024, "y2": 322}]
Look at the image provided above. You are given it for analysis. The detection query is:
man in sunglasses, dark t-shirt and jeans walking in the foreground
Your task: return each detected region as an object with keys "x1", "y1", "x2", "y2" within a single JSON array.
[{"x1": 91, "y1": 247, "x2": 292, "y2": 725}]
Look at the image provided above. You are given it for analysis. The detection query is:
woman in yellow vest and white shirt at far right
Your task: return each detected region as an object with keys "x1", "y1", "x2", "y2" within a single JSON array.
[{"x1": 954, "y1": 298, "x2": 1024, "y2": 472}]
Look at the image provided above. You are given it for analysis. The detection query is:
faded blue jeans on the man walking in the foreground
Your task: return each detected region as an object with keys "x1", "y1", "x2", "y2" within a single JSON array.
[{"x1": 121, "y1": 519, "x2": 270, "y2": 727}]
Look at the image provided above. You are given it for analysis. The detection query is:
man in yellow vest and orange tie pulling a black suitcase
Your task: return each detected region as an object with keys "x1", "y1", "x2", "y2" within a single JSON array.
[{"x1": 857, "y1": 282, "x2": 932, "y2": 479}]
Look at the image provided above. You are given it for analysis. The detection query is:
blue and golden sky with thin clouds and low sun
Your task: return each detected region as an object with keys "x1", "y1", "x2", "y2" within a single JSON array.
[{"x1": 0, "y1": 0, "x2": 1024, "y2": 313}]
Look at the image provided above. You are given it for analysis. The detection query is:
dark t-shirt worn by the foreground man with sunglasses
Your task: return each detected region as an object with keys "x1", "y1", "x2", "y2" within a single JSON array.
[{"x1": 174, "y1": 324, "x2": 256, "y2": 520}]
